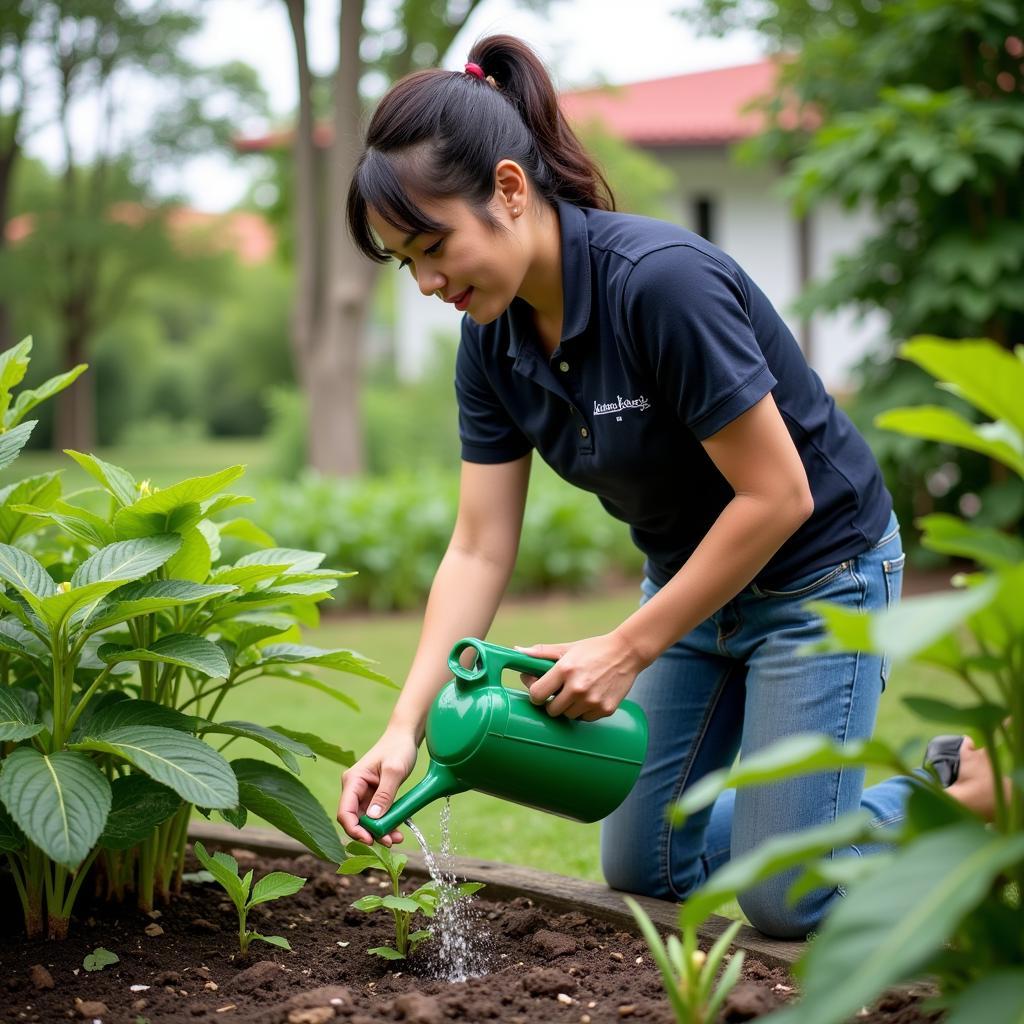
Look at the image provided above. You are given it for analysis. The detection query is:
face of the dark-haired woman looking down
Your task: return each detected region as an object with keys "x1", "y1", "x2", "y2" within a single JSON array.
[{"x1": 369, "y1": 199, "x2": 528, "y2": 324}]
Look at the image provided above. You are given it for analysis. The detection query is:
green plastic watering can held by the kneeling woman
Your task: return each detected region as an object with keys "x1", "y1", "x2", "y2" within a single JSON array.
[{"x1": 359, "y1": 638, "x2": 647, "y2": 839}]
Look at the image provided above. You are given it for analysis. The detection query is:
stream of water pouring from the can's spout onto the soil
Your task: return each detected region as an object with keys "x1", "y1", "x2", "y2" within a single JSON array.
[{"x1": 406, "y1": 800, "x2": 487, "y2": 981}]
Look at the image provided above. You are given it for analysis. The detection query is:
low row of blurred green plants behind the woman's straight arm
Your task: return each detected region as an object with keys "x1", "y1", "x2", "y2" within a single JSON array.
[{"x1": 243, "y1": 463, "x2": 641, "y2": 610}]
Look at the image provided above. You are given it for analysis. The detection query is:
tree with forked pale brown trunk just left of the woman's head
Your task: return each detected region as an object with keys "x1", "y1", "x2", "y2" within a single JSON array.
[{"x1": 286, "y1": 0, "x2": 505, "y2": 476}]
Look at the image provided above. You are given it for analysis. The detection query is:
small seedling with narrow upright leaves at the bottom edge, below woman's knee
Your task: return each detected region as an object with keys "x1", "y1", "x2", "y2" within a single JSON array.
[{"x1": 623, "y1": 896, "x2": 743, "y2": 1024}]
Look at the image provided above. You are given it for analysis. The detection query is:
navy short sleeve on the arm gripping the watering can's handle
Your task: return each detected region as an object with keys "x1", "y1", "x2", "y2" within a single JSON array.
[{"x1": 624, "y1": 245, "x2": 777, "y2": 440}]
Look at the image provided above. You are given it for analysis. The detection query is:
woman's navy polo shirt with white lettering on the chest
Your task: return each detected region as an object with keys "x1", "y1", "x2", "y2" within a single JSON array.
[{"x1": 456, "y1": 203, "x2": 892, "y2": 587}]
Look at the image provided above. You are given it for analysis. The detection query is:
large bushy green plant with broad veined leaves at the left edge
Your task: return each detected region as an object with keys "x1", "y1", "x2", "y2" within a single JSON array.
[{"x1": 0, "y1": 341, "x2": 393, "y2": 937}]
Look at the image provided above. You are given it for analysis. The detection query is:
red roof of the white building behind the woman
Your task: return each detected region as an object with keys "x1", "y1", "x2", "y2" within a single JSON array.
[{"x1": 560, "y1": 60, "x2": 778, "y2": 146}]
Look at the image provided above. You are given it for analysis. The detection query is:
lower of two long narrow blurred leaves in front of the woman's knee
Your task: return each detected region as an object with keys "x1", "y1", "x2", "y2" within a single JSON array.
[{"x1": 679, "y1": 811, "x2": 872, "y2": 926}]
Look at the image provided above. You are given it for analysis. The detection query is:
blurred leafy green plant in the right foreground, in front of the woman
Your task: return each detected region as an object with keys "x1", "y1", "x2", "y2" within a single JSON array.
[{"x1": 676, "y1": 337, "x2": 1024, "y2": 1024}]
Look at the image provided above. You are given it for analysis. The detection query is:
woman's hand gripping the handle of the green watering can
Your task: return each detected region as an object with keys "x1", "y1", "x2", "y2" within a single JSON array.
[{"x1": 516, "y1": 633, "x2": 645, "y2": 722}]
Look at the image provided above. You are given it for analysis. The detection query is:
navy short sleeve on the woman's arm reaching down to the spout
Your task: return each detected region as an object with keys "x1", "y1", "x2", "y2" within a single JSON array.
[{"x1": 455, "y1": 317, "x2": 534, "y2": 463}]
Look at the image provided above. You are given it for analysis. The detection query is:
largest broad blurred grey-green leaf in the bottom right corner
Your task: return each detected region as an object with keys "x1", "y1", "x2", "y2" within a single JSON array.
[{"x1": 775, "y1": 822, "x2": 1024, "y2": 1024}]
